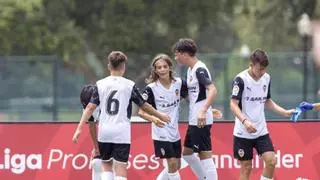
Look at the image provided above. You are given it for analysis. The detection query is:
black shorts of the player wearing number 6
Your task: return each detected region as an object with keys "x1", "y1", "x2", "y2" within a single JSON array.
[{"x1": 98, "y1": 142, "x2": 130, "y2": 163}]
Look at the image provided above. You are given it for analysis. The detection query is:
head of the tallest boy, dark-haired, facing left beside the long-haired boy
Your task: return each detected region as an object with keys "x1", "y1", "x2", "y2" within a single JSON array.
[{"x1": 172, "y1": 38, "x2": 197, "y2": 64}]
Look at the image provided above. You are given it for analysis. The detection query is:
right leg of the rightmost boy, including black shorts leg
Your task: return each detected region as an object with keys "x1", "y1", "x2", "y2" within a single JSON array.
[{"x1": 255, "y1": 134, "x2": 277, "y2": 180}]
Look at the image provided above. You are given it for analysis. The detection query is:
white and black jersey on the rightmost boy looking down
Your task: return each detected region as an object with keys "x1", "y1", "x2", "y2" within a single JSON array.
[{"x1": 231, "y1": 70, "x2": 271, "y2": 139}]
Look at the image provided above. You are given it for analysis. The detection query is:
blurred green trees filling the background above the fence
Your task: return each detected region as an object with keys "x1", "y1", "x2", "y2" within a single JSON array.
[{"x1": 0, "y1": 0, "x2": 319, "y2": 84}]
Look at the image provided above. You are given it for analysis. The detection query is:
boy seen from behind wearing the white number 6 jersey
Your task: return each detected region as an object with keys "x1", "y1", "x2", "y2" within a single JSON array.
[{"x1": 77, "y1": 51, "x2": 170, "y2": 180}]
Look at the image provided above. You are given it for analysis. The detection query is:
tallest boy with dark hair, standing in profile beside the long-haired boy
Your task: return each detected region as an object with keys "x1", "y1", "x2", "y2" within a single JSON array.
[{"x1": 173, "y1": 39, "x2": 218, "y2": 180}]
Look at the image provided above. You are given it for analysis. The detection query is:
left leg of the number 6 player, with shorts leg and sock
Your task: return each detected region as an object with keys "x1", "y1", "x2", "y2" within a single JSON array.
[{"x1": 98, "y1": 142, "x2": 113, "y2": 180}]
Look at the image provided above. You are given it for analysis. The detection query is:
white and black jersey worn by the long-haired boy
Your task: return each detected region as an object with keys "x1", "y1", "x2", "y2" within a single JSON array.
[{"x1": 142, "y1": 78, "x2": 187, "y2": 142}]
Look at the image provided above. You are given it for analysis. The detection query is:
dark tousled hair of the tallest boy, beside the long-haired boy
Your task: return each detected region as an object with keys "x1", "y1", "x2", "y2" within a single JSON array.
[{"x1": 172, "y1": 38, "x2": 197, "y2": 57}]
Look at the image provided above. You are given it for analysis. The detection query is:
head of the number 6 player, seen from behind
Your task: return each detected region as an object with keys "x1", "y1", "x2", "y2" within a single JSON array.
[{"x1": 107, "y1": 51, "x2": 127, "y2": 73}]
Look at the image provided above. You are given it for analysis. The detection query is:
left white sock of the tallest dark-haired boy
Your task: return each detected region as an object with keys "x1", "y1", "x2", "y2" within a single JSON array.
[{"x1": 183, "y1": 154, "x2": 206, "y2": 179}]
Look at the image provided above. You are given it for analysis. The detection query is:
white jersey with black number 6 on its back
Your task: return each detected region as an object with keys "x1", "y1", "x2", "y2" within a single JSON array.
[{"x1": 90, "y1": 76, "x2": 145, "y2": 144}]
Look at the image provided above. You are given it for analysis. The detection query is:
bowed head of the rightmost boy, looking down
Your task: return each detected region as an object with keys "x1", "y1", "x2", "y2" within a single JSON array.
[{"x1": 250, "y1": 49, "x2": 269, "y2": 78}]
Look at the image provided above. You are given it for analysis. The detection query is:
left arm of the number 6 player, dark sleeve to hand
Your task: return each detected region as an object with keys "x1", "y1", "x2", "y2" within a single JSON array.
[{"x1": 72, "y1": 87, "x2": 100, "y2": 143}]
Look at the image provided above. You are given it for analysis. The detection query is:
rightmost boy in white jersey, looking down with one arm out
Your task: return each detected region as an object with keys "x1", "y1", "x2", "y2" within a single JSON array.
[{"x1": 230, "y1": 49, "x2": 294, "y2": 180}]
